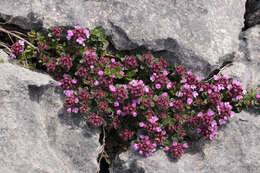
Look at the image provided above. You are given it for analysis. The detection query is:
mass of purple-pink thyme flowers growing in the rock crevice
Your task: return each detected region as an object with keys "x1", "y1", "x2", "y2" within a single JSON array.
[{"x1": 11, "y1": 26, "x2": 260, "y2": 161}]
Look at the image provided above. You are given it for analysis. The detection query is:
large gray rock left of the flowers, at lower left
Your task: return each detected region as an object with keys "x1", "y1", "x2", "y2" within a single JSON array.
[{"x1": 0, "y1": 59, "x2": 99, "y2": 173}]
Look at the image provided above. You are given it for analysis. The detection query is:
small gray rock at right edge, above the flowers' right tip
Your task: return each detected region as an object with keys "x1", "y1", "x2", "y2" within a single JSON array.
[{"x1": 222, "y1": 25, "x2": 260, "y2": 88}]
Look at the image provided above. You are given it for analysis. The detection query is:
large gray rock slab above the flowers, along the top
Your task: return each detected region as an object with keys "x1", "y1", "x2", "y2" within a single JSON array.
[{"x1": 0, "y1": 0, "x2": 246, "y2": 76}]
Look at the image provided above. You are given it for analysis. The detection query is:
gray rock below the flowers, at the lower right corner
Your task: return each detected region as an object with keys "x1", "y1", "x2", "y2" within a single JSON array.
[{"x1": 110, "y1": 112, "x2": 260, "y2": 173}]
